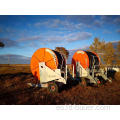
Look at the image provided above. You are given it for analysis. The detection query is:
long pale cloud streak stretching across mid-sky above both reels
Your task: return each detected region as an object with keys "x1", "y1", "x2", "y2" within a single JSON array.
[{"x1": 18, "y1": 32, "x2": 92, "y2": 44}]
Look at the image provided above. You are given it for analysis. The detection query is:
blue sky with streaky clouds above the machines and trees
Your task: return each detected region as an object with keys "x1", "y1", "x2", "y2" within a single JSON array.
[{"x1": 0, "y1": 15, "x2": 120, "y2": 57}]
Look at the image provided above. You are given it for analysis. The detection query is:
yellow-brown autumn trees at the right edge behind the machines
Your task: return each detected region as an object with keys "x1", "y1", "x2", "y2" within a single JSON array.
[{"x1": 89, "y1": 37, "x2": 120, "y2": 65}]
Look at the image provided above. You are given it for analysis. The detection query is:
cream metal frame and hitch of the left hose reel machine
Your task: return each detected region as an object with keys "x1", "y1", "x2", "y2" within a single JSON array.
[{"x1": 28, "y1": 62, "x2": 67, "y2": 87}]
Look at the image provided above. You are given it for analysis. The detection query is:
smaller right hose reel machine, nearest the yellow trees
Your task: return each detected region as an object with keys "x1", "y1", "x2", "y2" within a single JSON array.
[{"x1": 72, "y1": 50, "x2": 112, "y2": 85}]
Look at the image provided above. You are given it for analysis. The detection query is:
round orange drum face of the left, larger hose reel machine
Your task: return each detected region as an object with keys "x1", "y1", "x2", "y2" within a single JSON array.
[{"x1": 30, "y1": 48, "x2": 58, "y2": 80}]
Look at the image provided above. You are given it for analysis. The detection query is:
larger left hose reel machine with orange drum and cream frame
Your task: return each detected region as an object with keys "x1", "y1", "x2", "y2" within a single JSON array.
[{"x1": 30, "y1": 48, "x2": 67, "y2": 92}]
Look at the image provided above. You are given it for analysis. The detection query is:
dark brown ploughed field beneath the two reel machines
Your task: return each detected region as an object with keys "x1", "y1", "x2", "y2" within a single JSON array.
[{"x1": 0, "y1": 65, "x2": 120, "y2": 105}]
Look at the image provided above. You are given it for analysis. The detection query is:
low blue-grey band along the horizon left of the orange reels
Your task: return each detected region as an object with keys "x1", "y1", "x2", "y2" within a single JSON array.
[{"x1": 0, "y1": 54, "x2": 30, "y2": 64}]
